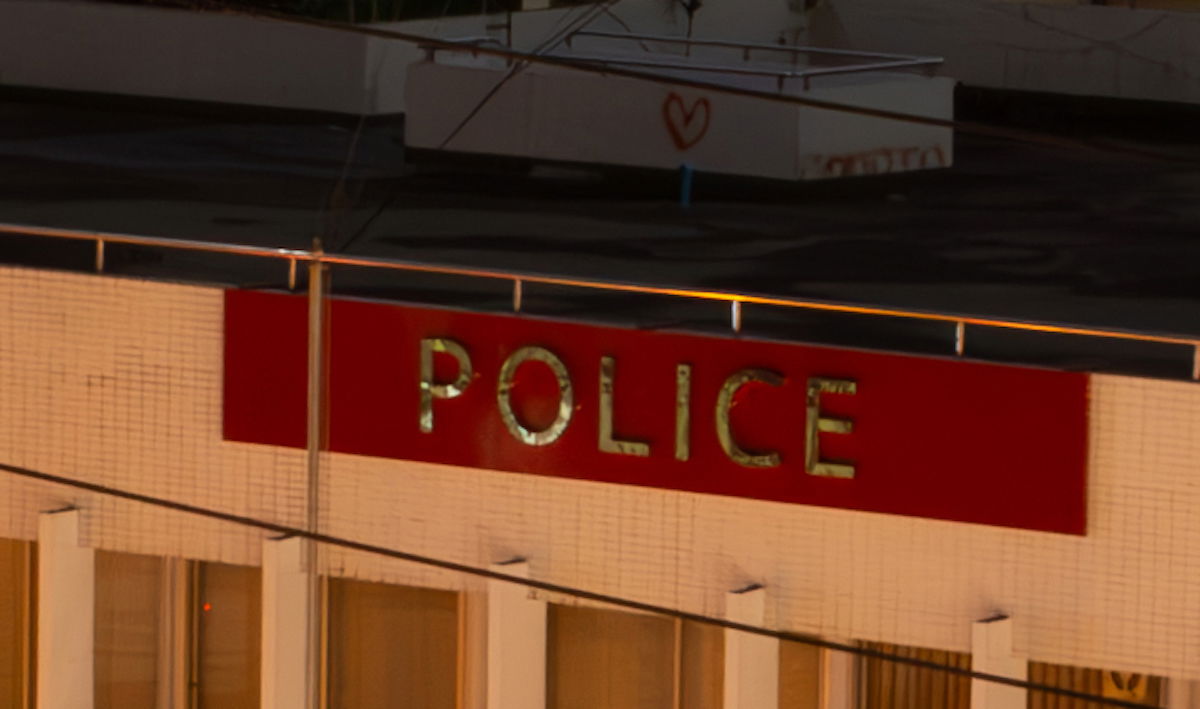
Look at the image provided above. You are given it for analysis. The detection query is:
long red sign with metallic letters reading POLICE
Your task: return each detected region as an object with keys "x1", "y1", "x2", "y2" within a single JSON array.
[{"x1": 224, "y1": 290, "x2": 1087, "y2": 534}]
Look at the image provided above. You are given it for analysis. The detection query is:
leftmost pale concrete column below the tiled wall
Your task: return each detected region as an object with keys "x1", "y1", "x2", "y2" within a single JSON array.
[{"x1": 37, "y1": 510, "x2": 96, "y2": 709}]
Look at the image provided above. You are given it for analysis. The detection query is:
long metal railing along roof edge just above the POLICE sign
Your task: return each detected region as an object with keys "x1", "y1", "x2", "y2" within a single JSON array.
[{"x1": 7, "y1": 223, "x2": 1200, "y2": 380}]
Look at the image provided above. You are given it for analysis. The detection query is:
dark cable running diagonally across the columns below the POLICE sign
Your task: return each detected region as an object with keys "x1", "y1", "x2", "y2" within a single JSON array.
[{"x1": 0, "y1": 463, "x2": 1151, "y2": 709}]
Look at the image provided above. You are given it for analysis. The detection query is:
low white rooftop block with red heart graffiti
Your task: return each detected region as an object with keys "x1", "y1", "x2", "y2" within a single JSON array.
[{"x1": 406, "y1": 61, "x2": 954, "y2": 180}]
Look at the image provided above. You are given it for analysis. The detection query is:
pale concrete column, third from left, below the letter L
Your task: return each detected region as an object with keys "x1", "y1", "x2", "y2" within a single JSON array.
[{"x1": 487, "y1": 560, "x2": 546, "y2": 709}]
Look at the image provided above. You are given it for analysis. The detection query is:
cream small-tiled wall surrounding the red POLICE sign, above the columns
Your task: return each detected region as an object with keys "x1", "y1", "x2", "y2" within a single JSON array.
[{"x1": 0, "y1": 269, "x2": 1200, "y2": 678}]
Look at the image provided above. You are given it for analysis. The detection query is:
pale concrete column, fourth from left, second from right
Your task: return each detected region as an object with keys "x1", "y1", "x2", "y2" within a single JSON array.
[{"x1": 724, "y1": 587, "x2": 779, "y2": 709}]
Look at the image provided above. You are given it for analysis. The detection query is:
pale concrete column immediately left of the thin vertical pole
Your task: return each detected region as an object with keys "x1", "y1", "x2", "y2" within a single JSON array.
[{"x1": 260, "y1": 536, "x2": 317, "y2": 709}]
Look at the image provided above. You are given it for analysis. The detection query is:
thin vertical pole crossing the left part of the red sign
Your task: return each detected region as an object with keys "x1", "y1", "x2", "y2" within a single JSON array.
[{"x1": 304, "y1": 239, "x2": 329, "y2": 709}]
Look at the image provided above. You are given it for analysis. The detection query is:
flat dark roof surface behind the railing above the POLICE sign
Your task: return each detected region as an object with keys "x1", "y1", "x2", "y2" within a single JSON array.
[{"x1": 0, "y1": 91, "x2": 1200, "y2": 377}]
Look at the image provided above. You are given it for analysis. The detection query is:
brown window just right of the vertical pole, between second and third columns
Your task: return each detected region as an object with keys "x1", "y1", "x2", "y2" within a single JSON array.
[{"x1": 328, "y1": 578, "x2": 458, "y2": 709}]
